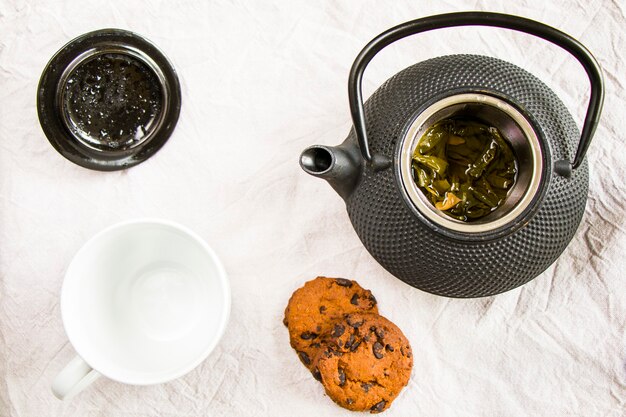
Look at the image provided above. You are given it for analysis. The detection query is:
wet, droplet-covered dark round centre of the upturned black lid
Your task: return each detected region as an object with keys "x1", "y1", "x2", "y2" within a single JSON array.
[{"x1": 61, "y1": 53, "x2": 163, "y2": 151}]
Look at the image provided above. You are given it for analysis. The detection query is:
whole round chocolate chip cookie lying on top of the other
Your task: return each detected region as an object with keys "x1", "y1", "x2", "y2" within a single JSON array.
[{"x1": 312, "y1": 313, "x2": 413, "y2": 413}]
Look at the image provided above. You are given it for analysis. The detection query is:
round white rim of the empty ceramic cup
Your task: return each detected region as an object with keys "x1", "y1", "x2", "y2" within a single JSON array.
[{"x1": 60, "y1": 217, "x2": 232, "y2": 385}]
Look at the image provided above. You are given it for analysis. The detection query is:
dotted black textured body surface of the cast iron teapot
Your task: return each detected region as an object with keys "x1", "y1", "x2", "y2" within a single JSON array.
[{"x1": 346, "y1": 55, "x2": 589, "y2": 297}]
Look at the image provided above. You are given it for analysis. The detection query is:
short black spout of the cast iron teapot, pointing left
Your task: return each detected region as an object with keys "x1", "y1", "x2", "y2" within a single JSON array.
[{"x1": 300, "y1": 143, "x2": 361, "y2": 200}]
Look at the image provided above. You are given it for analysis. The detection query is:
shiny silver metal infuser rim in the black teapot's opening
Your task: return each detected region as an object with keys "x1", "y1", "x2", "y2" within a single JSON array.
[{"x1": 400, "y1": 93, "x2": 544, "y2": 234}]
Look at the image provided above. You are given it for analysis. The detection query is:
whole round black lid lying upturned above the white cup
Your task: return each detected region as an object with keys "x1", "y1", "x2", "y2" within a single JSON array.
[{"x1": 37, "y1": 29, "x2": 181, "y2": 171}]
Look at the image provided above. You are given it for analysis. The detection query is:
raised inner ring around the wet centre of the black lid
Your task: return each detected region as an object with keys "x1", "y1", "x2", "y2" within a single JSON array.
[{"x1": 56, "y1": 42, "x2": 170, "y2": 154}]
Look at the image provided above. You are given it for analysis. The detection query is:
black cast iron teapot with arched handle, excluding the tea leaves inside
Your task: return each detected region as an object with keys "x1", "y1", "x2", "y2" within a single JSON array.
[{"x1": 300, "y1": 12, "x2": 604, "y2": 297}]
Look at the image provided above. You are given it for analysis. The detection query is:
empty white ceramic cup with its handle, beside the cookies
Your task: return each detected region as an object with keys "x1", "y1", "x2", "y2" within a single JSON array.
[{"x1": 52, "y1": 219, "x2": 231, "y2": 399}]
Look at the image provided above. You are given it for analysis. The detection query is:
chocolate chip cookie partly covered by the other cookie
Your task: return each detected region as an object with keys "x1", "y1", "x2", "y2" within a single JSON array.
[{"x1": 283, "y1": 277, "x2": 378, "y2": 370}]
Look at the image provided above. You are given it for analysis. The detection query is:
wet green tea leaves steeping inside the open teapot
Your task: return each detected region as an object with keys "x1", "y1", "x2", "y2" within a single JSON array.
[{"x1": 412, "y1": 118, "x2": 517, "y2": 221}]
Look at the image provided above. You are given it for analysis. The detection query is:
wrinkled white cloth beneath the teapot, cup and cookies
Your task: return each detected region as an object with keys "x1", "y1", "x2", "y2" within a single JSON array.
[{"x1": 0, "y1": 0, "x2": 626, "y2": 417}]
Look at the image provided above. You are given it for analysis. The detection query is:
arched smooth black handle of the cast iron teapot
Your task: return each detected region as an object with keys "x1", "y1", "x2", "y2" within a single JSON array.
[{"x1": 348, "y1": 12, "x2": 604, "y2": 176}]
